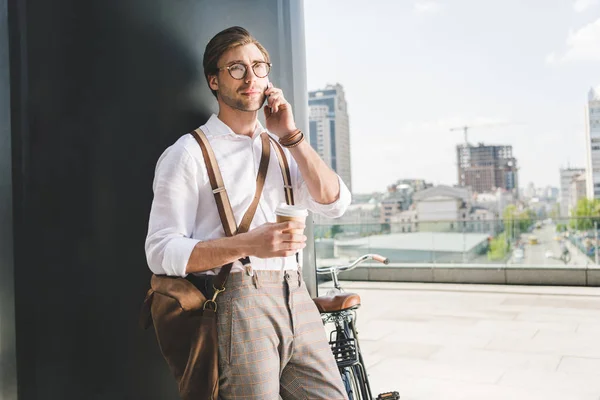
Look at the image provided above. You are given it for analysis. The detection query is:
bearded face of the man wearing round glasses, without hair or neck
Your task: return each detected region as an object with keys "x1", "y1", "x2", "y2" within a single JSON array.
[{"x1": 210, "y1": 43, "x2": 268, "y2": 111}]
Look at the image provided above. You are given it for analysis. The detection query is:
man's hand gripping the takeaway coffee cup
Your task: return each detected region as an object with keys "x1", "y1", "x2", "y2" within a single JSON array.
[{"x1": 239, "y1": 221, "x2": 306, "y2": 258}]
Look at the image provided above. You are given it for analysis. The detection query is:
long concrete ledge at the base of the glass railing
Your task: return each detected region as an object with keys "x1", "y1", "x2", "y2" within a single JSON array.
[{"x1": 340, "y1": 264, "x2": 600, "y2": 286}]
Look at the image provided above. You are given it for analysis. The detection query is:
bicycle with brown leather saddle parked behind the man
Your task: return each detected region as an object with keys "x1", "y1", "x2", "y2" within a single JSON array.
[{"x1": 313, "y1": 254, "x2": 400, "y2": 400}]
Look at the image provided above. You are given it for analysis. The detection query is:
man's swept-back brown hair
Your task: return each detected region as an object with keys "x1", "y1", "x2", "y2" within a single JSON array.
[{"x1": 202, "y1": 26, "x2": 271, "y2": 97}]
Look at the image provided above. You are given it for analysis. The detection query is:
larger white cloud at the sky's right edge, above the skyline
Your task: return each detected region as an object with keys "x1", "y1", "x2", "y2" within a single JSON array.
[{"x1": 546, "y1": 18, "x2": 600, "y2": 64}]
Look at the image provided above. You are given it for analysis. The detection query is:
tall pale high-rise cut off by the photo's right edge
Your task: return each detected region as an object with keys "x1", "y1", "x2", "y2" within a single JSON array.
[{"x1": 585, "y1": 86, "x2": 600, "y2": 199}]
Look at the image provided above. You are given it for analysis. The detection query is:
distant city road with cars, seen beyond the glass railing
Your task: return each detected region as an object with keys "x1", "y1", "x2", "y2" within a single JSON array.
[{"x1": 510, "y1": 225, "x2": 592, "y2": 266}]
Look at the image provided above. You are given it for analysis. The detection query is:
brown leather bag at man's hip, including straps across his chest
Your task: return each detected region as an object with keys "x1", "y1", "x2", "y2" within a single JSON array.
[{"x1": 140, "y1": 129, "x2": 294, "y2": 400}]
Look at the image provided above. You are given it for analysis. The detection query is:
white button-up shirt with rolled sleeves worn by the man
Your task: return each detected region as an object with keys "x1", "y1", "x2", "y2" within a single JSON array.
[{"x1": 145, "y1": 114, "x2": 351, "y2": 277}]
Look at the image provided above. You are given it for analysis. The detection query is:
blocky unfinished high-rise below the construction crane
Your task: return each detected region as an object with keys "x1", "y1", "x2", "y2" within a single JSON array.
[{"x1": 456, "y1": 143, "x2": 519, "y2": 196}]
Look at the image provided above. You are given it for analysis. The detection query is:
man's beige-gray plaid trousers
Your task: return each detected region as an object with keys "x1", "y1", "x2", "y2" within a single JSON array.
[{"x1": 217, "y1": 271, "x2": 348, "y2": 400}]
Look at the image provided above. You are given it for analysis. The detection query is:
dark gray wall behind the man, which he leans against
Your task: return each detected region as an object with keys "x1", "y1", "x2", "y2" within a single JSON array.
[{"x1": 0, "y1": 0, "x2": 314, "y2": 400}]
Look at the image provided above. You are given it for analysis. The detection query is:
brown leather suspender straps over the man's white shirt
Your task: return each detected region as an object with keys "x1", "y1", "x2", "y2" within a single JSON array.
[{"x1": 192, "y1": 129, "x2": 294, "y2": 290}]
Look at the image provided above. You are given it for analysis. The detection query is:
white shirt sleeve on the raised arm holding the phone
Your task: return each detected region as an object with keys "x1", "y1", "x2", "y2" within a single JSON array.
[{"x1": 286, "y1": 149, "x2": 352, "y2": 218}]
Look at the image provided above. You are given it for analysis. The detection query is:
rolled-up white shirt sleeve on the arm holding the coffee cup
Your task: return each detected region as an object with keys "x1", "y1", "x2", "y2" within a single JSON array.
[{"x1": 145, "y1": 145, "x2": 199, "y2": 277}]
